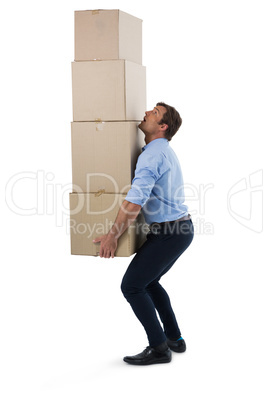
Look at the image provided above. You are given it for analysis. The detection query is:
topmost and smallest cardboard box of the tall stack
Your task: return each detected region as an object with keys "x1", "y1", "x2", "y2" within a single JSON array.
[{"x1": 74, "y1": 10, "x2": 142, "y2": 64}]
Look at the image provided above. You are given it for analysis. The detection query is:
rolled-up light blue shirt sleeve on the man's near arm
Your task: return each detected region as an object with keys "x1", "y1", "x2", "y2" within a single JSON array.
[{"x1": 125, "y1": 152, "x2": 167, "y2": 207}]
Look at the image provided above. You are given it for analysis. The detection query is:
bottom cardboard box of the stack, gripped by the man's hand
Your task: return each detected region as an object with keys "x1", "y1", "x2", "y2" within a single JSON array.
[{"x1": 69, "y1": 192, "x2": 148, "y2": 257}]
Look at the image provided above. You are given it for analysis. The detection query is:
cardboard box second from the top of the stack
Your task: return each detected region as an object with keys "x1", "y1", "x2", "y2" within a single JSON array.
[{"x1": 72, "y1": 60, "x2": 146, "y2": 121}]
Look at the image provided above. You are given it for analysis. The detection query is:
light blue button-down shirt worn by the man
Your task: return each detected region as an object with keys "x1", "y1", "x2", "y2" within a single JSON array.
[{"x1": 125, "y1": 138, "x2": 188, "y2": 224}]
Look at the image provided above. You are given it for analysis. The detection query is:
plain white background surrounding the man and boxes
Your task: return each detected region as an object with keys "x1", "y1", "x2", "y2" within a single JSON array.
[{"x1": 0, "y1": 0, "x2": 268, "y2": 402}]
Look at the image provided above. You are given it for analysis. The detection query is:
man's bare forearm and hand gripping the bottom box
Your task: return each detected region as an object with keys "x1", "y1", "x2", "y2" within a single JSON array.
[{"x1": 93, "y1": 200, "x2": 141, "y2": 258}]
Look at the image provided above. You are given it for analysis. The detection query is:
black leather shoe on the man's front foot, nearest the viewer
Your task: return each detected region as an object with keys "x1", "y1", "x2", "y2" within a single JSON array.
[{"x1": 123, "y1": 346, "x2": 171, "y2": 366}]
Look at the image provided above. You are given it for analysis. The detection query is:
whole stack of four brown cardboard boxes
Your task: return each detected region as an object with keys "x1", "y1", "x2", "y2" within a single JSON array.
[{"x1": 70, "y1": 10, "x2": 146, "y2": 256}]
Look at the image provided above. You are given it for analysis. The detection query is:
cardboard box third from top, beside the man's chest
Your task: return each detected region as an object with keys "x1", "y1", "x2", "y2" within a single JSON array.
[{"x1": 71, "y1": 121, "x2": 145, "y2": 193}]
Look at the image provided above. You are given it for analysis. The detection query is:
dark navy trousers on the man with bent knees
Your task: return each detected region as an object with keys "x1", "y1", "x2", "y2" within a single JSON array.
[{"x1": 121, "y1": 219, "x2": 194, "y2": 347}]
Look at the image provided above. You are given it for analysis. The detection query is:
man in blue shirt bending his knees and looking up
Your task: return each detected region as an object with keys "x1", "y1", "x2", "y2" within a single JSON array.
[{"x1": 94, "y1": 102, "x2": 194, "y2": 365}]
